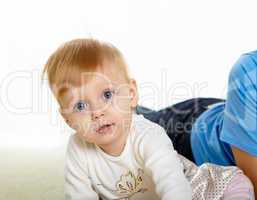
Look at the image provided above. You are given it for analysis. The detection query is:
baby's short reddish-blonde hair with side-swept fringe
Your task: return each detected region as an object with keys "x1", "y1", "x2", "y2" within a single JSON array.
[{"x1": 42, "y1": 39, "x2": 129, "y2": 97}]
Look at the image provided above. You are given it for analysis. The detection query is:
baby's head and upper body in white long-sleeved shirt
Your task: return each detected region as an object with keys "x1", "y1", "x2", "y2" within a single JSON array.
[{"x1": 44, "y1": 39, "x2": 192, "y2": 200}]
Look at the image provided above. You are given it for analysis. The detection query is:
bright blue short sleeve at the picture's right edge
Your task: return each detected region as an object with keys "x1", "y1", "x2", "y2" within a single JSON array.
[{"x1": 220, "y1": 52, "x2": 257, "y2": 156}]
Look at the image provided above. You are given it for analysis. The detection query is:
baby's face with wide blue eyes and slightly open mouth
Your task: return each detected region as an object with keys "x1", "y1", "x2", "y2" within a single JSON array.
[{"x1": 55, "y1": 65, "x2": 137, "y2": 147}]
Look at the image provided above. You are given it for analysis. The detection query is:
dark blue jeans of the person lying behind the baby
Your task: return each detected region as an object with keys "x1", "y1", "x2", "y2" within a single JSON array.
[{"x1": 136, "y1": 98, "x2": 224, "y2": 162}]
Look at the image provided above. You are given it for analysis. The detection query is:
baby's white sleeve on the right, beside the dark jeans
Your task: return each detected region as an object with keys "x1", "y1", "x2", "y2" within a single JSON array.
[{"x1": 139, "y1": 125, "x2": 192, "y2": 200}]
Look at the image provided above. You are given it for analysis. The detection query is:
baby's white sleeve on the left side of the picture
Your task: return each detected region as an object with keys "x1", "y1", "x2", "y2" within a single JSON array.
[{"x1": 65, "y1": 135, "x2": 99, "y2": 200}]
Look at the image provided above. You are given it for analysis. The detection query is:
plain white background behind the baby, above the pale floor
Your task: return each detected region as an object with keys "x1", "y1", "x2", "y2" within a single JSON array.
[{"x1": 0, "y1": 0, "x2": 257, "y2": 148}]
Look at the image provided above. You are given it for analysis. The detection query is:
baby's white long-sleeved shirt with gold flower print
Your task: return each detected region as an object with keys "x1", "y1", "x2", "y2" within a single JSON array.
[{"x1": 65, "y1": 114, "x2": 191, "y2": 200}]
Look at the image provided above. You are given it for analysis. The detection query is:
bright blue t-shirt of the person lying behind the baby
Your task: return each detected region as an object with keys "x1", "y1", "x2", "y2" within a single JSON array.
[{"x1": 191, "y1": 51, "x2": 257, "y2": 165}]
